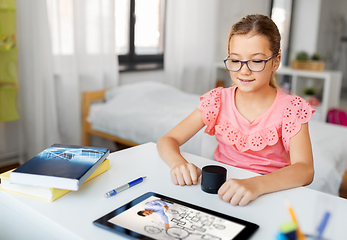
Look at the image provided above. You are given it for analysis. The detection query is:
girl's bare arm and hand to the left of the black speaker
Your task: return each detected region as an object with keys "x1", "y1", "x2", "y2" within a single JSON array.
[{"x1": 157, "y1": 109, "x2": 205, "y2": 186}]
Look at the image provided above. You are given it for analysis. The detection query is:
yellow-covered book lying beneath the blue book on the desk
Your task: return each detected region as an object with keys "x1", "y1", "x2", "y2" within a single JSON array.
[{"x1": 0, "y1": 159, "x2": 110, "y2": 202}]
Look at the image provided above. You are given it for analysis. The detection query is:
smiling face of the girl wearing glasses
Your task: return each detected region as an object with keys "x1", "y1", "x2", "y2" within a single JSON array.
[{"x1": 228, "y1": 33, "x2": 280, "y2": 92}]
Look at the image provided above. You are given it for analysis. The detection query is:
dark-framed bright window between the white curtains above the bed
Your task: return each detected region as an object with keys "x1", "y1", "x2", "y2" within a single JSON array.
[{"x1": 115, "y1": 0, "x2": 165, "y2": 71}]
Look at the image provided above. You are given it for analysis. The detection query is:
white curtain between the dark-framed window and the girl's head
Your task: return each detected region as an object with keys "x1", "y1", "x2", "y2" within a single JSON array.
[{"x1": 164, "y1": 0, "x2": 219, "y2": 94}]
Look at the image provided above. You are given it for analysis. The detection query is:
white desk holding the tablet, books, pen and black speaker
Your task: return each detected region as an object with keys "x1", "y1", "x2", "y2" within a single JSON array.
[{"x1": 0, "y1": 143, "x2": 347, "y2": 240}]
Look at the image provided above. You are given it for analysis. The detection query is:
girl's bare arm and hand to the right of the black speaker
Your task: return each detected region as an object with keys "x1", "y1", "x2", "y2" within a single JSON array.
[{"x1": 218, "y1": 123, "x2": 314, "y2": 206}]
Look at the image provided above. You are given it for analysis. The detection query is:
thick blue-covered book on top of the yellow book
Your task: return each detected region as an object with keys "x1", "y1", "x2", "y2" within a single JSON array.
[{"x1": 10, "y1": 144, "x2": 110, "y2": 191}]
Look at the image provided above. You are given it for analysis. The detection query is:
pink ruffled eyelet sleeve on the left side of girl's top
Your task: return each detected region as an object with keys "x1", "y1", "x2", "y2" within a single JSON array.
[{"x1": 198, "y1": 87, "x2": 223, "y2": 135}]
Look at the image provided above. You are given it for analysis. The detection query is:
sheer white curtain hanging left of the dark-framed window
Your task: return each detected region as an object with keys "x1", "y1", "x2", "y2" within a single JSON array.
[{"x1": 16, "y1": 0, "x2": 119, "y2": 157}]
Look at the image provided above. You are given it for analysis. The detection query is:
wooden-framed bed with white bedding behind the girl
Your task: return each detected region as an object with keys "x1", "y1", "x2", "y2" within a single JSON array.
[{"x1": 82, "y1": 82, "x2": 347, "y2": 196}]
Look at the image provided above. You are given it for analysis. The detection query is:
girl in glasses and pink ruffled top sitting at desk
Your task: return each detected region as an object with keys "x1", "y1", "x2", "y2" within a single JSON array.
[{"x1": 157, "y1": 15, "x2": 314, "y2": 206}]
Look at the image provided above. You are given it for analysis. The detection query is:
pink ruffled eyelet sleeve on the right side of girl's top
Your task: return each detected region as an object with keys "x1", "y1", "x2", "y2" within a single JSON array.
[{"x1": 282, "y1": 95, "x2": 315, "y2": 152}]
